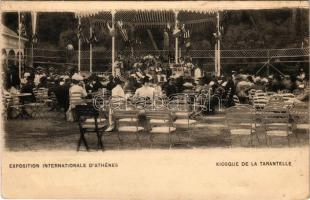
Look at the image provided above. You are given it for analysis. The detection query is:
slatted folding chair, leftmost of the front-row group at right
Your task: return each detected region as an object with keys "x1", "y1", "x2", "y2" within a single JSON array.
[{"x1": 226, "y1": 105, "x2": 259, "y2": 146}]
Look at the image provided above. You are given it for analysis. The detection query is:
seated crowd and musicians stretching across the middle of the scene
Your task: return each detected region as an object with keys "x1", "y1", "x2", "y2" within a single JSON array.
[{"x1": 5, "y1": 55, "x2": 308, "y2": 122}]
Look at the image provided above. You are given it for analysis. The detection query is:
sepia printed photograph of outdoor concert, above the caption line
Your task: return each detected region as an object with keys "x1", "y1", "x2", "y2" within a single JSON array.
[{"x1": 1, "y1": 2, "x2": 309, "y2": 152}]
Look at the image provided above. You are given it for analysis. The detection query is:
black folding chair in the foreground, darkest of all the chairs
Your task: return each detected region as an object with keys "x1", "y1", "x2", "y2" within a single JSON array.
[{"x1": 75, "y1": 105, "x2": 106, "y2": 151}]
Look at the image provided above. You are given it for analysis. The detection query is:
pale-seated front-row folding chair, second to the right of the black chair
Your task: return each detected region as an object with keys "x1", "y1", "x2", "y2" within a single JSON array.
[{"x1": 145, "y1": 110, "x2": 176, "y2": 148}]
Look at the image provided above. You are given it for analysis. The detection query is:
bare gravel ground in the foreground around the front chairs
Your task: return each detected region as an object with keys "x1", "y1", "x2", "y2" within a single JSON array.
[{"x1": 4, "y1": 111, "x2": 309, "y2": 151}]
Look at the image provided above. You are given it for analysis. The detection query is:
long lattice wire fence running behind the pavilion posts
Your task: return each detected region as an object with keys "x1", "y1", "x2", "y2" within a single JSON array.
[{"x1": 25, "y1": 48, "x2": 309, "y2": 67}]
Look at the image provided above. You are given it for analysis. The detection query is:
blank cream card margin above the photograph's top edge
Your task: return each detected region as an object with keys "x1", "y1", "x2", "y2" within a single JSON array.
[{"x1": 1, "y1": 1, "x2": 309, "y2": 12}]
